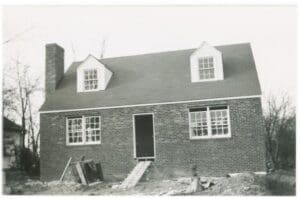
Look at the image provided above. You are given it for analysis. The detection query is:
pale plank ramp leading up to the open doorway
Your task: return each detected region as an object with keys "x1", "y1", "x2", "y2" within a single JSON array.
[{"x1": 119, "y1": 161, "x2": 151, "y2": 189}]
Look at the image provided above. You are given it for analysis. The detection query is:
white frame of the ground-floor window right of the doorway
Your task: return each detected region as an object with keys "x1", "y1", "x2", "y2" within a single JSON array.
[{"x1": 188, "y1": 105, "x2": 231, "y2": 140}]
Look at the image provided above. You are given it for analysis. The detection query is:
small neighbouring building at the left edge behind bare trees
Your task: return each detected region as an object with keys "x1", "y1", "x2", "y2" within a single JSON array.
[{"x1": 2, "y1": 117, "x2": 23, "y2": 169}]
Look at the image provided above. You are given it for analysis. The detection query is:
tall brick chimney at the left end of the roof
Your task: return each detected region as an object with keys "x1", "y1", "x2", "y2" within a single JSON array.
[{"x1": 45, "y1": 44, "x2": 64, "y2": 97}]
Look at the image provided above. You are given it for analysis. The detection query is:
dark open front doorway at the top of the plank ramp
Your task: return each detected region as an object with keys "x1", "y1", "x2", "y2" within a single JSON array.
[{"x1": 134, "y1": 114, "x2": 154, "y2": 158}]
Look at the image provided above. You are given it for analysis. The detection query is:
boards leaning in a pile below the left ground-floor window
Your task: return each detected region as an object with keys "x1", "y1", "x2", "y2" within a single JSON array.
[{"x1": 59, "y1": 157, "x2": 103, "y2": 186}]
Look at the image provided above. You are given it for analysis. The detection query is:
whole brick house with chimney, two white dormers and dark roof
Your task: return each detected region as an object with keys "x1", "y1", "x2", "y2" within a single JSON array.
[{"x1": 40, "y1": 42, "x2": 265, "y2": 180}]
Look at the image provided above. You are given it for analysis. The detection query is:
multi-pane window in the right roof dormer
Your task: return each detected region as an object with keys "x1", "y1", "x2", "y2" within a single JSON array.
[{"x1": 199, "y1": 57, "x2": 215, "y2": 80}]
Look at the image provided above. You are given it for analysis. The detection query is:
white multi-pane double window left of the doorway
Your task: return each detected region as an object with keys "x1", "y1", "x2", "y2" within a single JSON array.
[{"x1": 67, "y1": 116, "x2": 101, "y2": 145}]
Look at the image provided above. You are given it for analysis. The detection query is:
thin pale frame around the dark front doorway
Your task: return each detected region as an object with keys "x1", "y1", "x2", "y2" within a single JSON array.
[{"x1": 132, "y1": 112, "x2": 156, "y2": 159}]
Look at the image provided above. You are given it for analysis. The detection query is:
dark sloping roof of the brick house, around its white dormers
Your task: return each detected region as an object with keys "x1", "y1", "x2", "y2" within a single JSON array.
[{"x1": 40, "y1": 43, "x2": 261, "y2": 111}]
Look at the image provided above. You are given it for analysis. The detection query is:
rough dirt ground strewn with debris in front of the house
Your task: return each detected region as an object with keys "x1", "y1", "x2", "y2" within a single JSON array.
[{"x1": 4, "y1": 170, "x2": 288, "y2": 195}]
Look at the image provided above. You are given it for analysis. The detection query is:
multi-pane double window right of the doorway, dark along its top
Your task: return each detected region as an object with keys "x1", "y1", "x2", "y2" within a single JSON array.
[{"x1": 189, "y1": 106, "x2": 231, "y2": 138}]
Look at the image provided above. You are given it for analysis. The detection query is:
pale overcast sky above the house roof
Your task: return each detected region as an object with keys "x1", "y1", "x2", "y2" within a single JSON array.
[{"x1": 2, "y1": 6, "x2": 297, "y2": 108}]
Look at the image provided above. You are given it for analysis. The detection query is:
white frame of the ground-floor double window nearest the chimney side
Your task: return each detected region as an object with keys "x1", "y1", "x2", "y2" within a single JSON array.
[{"x1": 66, "y1": 115, "x2": 102, "y2": 146}]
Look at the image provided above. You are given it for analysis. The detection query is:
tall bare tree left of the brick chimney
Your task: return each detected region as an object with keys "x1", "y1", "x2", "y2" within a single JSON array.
[{"x1": 3, "y1": 59, "x2": 41, "y2": 154}]
